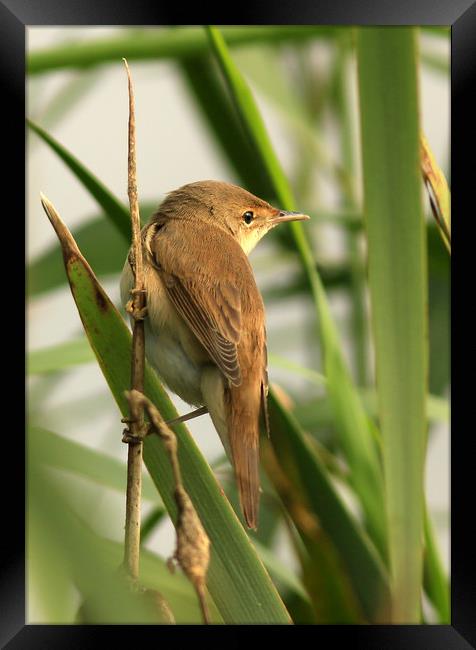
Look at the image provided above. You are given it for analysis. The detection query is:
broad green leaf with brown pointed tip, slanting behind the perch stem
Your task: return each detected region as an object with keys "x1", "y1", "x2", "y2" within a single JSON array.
[{"x1": 44, "y1": 194, "x2": 290, "y2": 623}]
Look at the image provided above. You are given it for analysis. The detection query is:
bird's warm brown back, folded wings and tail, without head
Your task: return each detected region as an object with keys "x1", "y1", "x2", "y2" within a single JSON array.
[{"x1": 150, "y1": 215, "x2": 267, "y2": 528}]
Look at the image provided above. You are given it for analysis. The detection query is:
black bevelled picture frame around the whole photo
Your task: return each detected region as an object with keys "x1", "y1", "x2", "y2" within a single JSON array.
[{"x1": 7, "y1": 0, "x2": 476, "y2": 650}]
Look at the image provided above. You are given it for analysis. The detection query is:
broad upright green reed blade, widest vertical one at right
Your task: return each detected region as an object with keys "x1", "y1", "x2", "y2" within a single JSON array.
[{"x1": 357, "y1": 28, "x2": 428, "y2": 623}]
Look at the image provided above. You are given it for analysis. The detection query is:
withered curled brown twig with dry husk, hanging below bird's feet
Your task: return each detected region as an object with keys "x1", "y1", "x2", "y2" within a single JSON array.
[{"x1": 126, "y1": 390, "x2": 210, "y2": 623}]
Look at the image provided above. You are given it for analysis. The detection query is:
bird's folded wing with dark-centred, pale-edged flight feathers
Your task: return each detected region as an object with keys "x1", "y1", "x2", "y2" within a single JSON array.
[{"x1": 151, "y1": 230, "x2": 241, "y2": 386}]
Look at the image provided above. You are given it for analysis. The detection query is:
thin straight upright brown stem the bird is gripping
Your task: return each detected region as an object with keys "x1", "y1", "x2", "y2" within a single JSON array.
[{"x1": 123, "y1": 59, "x2": 145, "y2": 582}]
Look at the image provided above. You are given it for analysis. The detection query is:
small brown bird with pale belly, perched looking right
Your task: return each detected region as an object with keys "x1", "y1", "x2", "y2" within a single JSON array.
[{"x1": 121, "y1": 181, "x2": 307, "y2": 528}]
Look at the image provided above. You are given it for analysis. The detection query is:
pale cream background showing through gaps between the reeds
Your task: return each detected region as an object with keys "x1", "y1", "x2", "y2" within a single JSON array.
[{"x1": 26, "y1": 27, "x2": 449, "y2": 622}]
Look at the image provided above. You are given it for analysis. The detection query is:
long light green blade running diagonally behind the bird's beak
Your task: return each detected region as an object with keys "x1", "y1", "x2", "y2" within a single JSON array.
[{"x1": 208, "y1": 27, "x2": 385, "y2": 555}]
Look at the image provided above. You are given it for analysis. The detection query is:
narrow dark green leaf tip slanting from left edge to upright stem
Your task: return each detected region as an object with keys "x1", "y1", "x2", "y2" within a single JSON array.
[{"x1": 27, "y1": 120, "x2": 131, "y2": 242}]
